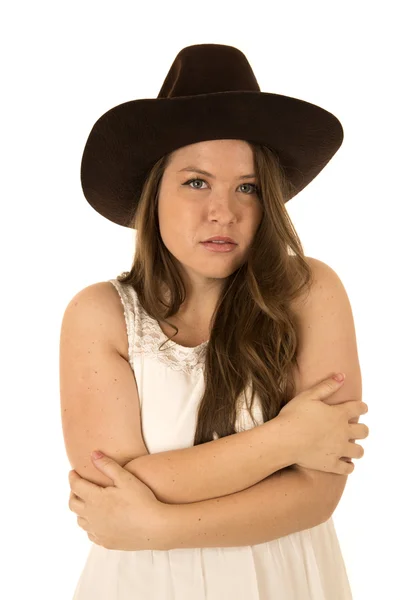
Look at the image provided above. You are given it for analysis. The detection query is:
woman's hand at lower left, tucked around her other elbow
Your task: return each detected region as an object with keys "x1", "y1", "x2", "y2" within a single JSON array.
[{"x1": 69, "y1": 456, "x2": 164, "y2": 550}]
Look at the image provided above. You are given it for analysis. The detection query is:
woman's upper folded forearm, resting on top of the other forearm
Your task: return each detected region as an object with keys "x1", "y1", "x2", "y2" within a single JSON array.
[{"x1": 124, "y1": 418, "x2": 295, "y2": 504}]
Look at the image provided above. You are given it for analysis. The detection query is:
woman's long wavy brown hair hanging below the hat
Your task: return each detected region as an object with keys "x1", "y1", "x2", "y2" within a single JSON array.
[{"x1": 117, "y1": 142, "x2": 312, "y2": 446}]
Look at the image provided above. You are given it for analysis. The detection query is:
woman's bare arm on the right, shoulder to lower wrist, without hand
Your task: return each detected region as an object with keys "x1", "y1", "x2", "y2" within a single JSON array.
[{"x1": 123, "y1": 257, "x2": 362, "y2": 549}]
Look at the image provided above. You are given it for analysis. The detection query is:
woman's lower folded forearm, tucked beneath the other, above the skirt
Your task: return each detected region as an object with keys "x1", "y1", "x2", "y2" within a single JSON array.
[{"x1": 160, "y1": 469, "x2": 331, "y2": 550}]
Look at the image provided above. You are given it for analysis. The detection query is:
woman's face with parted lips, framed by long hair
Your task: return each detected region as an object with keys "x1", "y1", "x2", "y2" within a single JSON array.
[{"x1": 158, "y1": 140, "x2": 262, "y2": 300}]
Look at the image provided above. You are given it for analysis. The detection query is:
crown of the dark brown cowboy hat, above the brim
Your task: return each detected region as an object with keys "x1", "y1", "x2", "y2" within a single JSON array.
[{"x1": 157, "y1": 44, "x2": 260, "y2": 98}]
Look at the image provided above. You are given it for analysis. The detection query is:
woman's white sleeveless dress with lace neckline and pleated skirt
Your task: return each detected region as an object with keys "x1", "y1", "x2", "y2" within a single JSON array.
[{"x1": 73, "y1": 279, "x2": 352, "y2": 600}]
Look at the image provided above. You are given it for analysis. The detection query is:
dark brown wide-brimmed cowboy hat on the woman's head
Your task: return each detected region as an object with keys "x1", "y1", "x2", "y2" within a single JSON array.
[{"x1": 81, "y1": 44, "x2": 343, "y2": 227}]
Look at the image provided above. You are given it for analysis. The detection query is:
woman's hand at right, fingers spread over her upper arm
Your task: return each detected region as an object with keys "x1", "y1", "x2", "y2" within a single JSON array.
[{"x1": 277, "y1": 377, "x2": 369, "y2": 475}]
